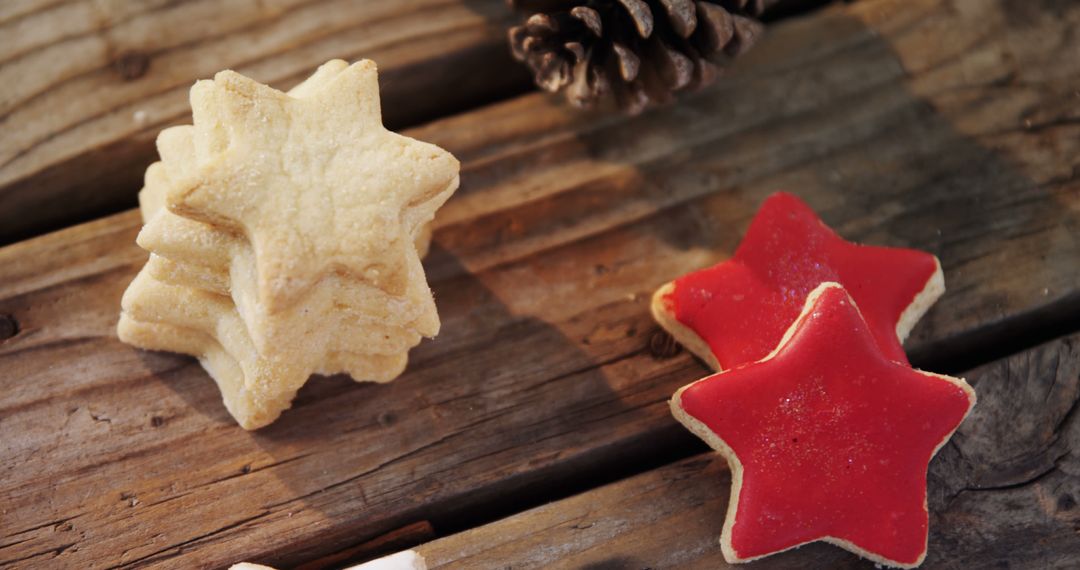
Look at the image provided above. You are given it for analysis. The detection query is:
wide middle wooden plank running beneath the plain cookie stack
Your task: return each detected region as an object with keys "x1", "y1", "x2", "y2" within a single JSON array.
[{"x1": 0, "y1": 0, "x2": 1080, "y2": 568}]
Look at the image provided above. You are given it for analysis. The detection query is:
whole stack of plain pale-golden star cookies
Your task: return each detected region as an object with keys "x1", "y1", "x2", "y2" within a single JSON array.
[{"x1": 118, "y1": 60, "x2": 458, "y2": 430}]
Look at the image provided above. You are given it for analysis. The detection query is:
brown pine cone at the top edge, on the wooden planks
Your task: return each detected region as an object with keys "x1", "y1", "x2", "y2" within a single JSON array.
[{"x1": 508, "y1": 0, "x2": 775, "y2": 114}]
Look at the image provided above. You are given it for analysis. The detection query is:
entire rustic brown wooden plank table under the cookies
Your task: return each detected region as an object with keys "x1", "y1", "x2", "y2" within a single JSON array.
[{"x1": 0, "y1": 0, "x2": 1080, "y2": 569}]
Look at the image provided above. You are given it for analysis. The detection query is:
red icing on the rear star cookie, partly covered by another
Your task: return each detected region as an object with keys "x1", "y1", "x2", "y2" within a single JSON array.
[{"x1": 667, "y1": 192, "x2": 937, "y2": 369}]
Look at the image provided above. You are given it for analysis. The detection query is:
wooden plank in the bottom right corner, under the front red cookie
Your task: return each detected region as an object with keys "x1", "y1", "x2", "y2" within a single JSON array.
[{"x1": 417, "y1": 335, "x2": 1080, "y2": 570}]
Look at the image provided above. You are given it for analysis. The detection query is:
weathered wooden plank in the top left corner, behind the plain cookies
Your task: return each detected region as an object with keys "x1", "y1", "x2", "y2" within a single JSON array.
[{"x1": 0, "y1": 0, "x2": 530, "y2": 243}]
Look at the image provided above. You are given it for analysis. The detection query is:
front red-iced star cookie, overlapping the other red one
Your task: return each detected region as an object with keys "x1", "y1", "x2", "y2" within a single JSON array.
[{"x1": 671, "y1": 283, "x2": 975, "y2": 568}]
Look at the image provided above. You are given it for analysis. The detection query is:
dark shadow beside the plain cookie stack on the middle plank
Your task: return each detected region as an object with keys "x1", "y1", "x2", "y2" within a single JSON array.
[{"x1": 99, "y1": 245, "x2": 665, "y2": 566}]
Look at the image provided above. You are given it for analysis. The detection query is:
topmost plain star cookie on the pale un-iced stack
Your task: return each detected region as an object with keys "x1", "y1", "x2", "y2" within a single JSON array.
[{"x1": 167, "y1": 60, "x2": 458, "y2": 313}]
